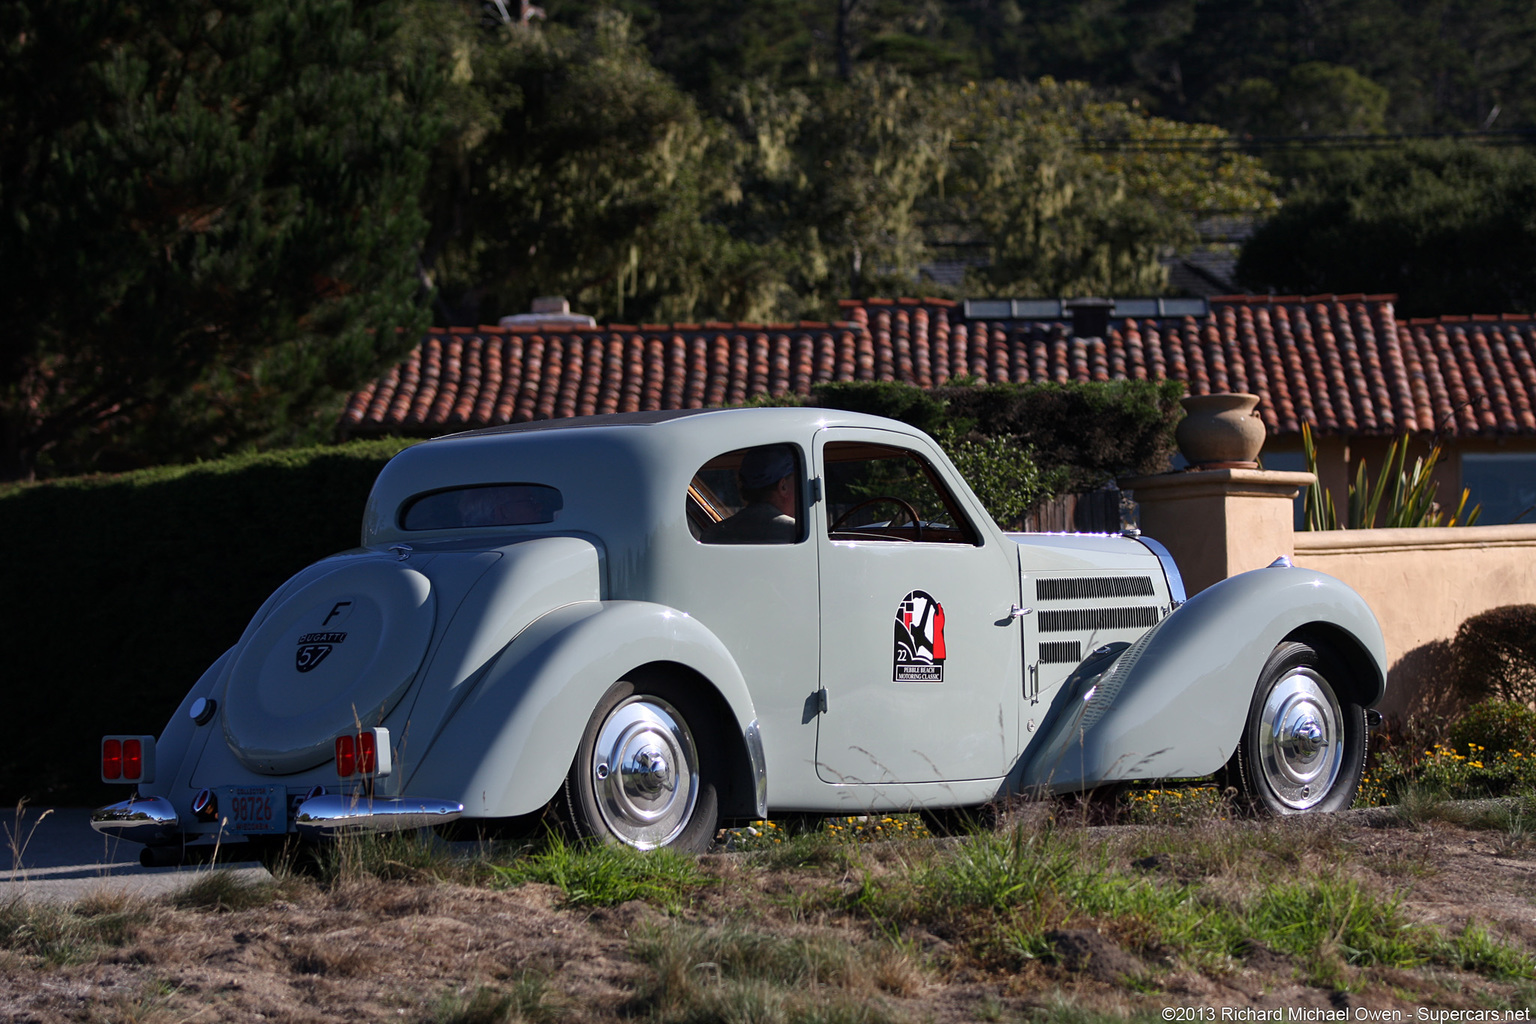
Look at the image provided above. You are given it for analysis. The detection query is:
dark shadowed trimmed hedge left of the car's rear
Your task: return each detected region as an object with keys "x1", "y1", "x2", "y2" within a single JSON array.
[{"x1": 0, "y1": 439, "x2": 413, "y2": 804}]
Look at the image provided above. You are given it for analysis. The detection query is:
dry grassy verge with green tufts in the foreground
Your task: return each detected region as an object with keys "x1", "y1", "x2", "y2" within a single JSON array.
[{"x1": 0, "y1": 804, "x2": 1536, "y2": 1024}]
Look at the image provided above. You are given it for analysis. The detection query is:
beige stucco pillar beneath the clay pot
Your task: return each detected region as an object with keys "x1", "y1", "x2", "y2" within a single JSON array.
[{"x1": 1120, "y1": 470, "x2": 1316, "y2": 594}]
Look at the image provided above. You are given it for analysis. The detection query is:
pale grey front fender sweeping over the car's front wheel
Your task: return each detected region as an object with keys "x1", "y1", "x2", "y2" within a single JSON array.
[{"x1": 1015, "y1": 567, "x2": 1387, "y2": 791}]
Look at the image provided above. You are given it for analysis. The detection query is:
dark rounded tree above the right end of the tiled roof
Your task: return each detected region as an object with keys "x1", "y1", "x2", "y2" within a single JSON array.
[{"x1": 1236, "y1": 144, "x2": 1536, "y2": 316}]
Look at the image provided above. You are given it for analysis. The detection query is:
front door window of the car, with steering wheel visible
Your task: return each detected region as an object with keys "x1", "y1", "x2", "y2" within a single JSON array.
[{"x1": 822, "y1": 441, "x2": 978, "y2": 545}]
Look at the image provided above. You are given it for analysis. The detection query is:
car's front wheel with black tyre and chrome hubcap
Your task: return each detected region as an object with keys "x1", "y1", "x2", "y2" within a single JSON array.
[{"x1": 1232, "y1": 642, "x2": 1367, "y2": 814}]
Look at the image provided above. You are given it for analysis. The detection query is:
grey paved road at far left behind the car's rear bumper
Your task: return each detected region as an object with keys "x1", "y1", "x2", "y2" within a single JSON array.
[{"x1": 0, "y1": 806, "x2": 270, "y2": 906}]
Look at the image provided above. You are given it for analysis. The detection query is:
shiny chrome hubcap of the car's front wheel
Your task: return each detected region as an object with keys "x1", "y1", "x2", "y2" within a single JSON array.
[{"x1": 1258, "y1": 669, "x2": 1344, "y2": 811}]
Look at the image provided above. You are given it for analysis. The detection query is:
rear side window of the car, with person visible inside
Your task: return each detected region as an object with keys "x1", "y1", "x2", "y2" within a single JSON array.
[{"x1": 688, "y1": 444, "x2": 805, "y2": 543}]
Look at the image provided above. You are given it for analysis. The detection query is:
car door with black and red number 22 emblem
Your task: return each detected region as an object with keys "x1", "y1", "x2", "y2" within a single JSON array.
[{"x1": 813, "y1": 427, "x2": 1021, "y2": 785}]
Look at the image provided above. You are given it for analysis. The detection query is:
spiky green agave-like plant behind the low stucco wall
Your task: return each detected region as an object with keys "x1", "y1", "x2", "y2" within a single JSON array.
[{"x1": 1301, "y1": 424, "x2": 1482, "y2": 530}]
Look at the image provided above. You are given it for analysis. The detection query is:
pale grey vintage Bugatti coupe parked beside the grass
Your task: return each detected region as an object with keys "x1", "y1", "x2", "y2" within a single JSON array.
[{"x1": 92, "y1": 408, "x2": 1385, "y2": 863}]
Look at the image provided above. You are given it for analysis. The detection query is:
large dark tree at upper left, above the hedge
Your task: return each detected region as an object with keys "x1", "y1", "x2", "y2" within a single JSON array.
[{"x1": 0, "y1": 0, "x2": 432, "y2": 477}]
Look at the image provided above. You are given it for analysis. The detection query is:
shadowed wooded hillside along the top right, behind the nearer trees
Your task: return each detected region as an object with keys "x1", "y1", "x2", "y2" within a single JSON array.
[{"x1": 559, "y1": 0, "x2": 1536, "y2": 135}]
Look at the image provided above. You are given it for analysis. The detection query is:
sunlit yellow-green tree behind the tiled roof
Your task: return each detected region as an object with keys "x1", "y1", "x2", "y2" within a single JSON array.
[{"x1": 951, "y1": 78, "x2": 1275, "y2": 296}]
